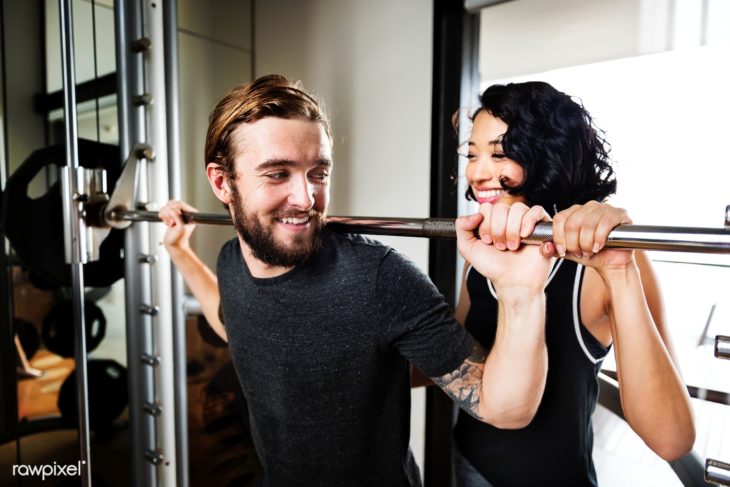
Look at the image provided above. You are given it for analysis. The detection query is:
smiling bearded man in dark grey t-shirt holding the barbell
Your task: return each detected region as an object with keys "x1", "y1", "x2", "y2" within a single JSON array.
[{"x1": 160, "y1": 75, "x2": 550, "y2": 486}]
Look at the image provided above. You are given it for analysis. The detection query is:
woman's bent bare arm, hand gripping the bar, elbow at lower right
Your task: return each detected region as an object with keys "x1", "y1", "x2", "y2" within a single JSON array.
[{"x1": 553, "y1": 202, "x2": 695, "y2": 460}]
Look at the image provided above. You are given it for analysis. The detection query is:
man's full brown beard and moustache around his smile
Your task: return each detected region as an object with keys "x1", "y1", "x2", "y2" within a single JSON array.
[{"x1": 230, "y1": 182, "x2": 324, "y2": 267}]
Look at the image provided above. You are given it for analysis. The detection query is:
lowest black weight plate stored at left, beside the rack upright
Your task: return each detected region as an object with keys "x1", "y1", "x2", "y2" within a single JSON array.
[{"x1": 58, "y1": 359, "x2": 128, "y2": 430}]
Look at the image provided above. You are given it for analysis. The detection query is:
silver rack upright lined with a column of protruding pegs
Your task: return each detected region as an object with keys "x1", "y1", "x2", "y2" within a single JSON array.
[{"x1": 114, "y1": 0, "x2": 157, "y2": 486}]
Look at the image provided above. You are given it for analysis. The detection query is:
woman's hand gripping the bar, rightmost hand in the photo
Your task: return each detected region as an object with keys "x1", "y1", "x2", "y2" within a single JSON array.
[{"x1": 553, "y1": 201, "x2": 634, "y2": 270}]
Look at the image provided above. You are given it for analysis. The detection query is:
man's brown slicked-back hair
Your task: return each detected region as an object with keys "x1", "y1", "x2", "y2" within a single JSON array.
[{"x1": 205, "y1": 74, "x2": 332, "y2": 178}]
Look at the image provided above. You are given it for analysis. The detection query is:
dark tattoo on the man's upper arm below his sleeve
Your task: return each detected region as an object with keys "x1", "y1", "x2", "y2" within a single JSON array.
[{"x1": 431, "y1": 345, "x2": 487, "y2": 421}]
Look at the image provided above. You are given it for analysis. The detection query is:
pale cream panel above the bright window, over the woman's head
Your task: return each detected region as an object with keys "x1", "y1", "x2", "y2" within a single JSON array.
[{"x1": 479, "y1": 0, "x2": 730, "y2": 80}]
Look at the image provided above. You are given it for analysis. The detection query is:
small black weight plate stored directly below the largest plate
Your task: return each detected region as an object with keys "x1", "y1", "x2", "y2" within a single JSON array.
[{"x1": 41, "y1": 300, "x2": 106, "y2": 358}]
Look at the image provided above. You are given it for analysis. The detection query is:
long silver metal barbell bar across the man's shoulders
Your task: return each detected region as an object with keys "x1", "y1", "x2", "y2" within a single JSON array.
[{"x1": 107, "y1": 209, "x2": 730, "y2": 254}]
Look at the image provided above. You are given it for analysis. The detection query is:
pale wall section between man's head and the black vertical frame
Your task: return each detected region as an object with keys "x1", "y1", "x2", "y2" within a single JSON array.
[{"x1": 254, "y1": 0, "x2": 433, "y2": 474}]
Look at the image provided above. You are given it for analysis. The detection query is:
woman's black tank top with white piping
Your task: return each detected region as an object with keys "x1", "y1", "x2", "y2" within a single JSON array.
[{"x1": 454, "y1": 260, "x2": 608, "y2": 487}]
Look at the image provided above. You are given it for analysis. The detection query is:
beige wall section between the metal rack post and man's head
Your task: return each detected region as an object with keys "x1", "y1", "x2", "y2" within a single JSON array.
[{"x1": 178, "y1": 0, "x2": 253, "y2": 269}]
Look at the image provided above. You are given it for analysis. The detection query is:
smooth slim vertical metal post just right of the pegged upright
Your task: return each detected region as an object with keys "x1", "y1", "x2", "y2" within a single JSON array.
[{"x1": 162, "y1": 0, "x2": 189, "y2": 487}]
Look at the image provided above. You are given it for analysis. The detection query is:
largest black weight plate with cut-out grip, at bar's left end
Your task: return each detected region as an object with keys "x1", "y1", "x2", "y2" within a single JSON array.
[{"x1": 0, "y1": 139, "x2": 124, "y2": 288}]
